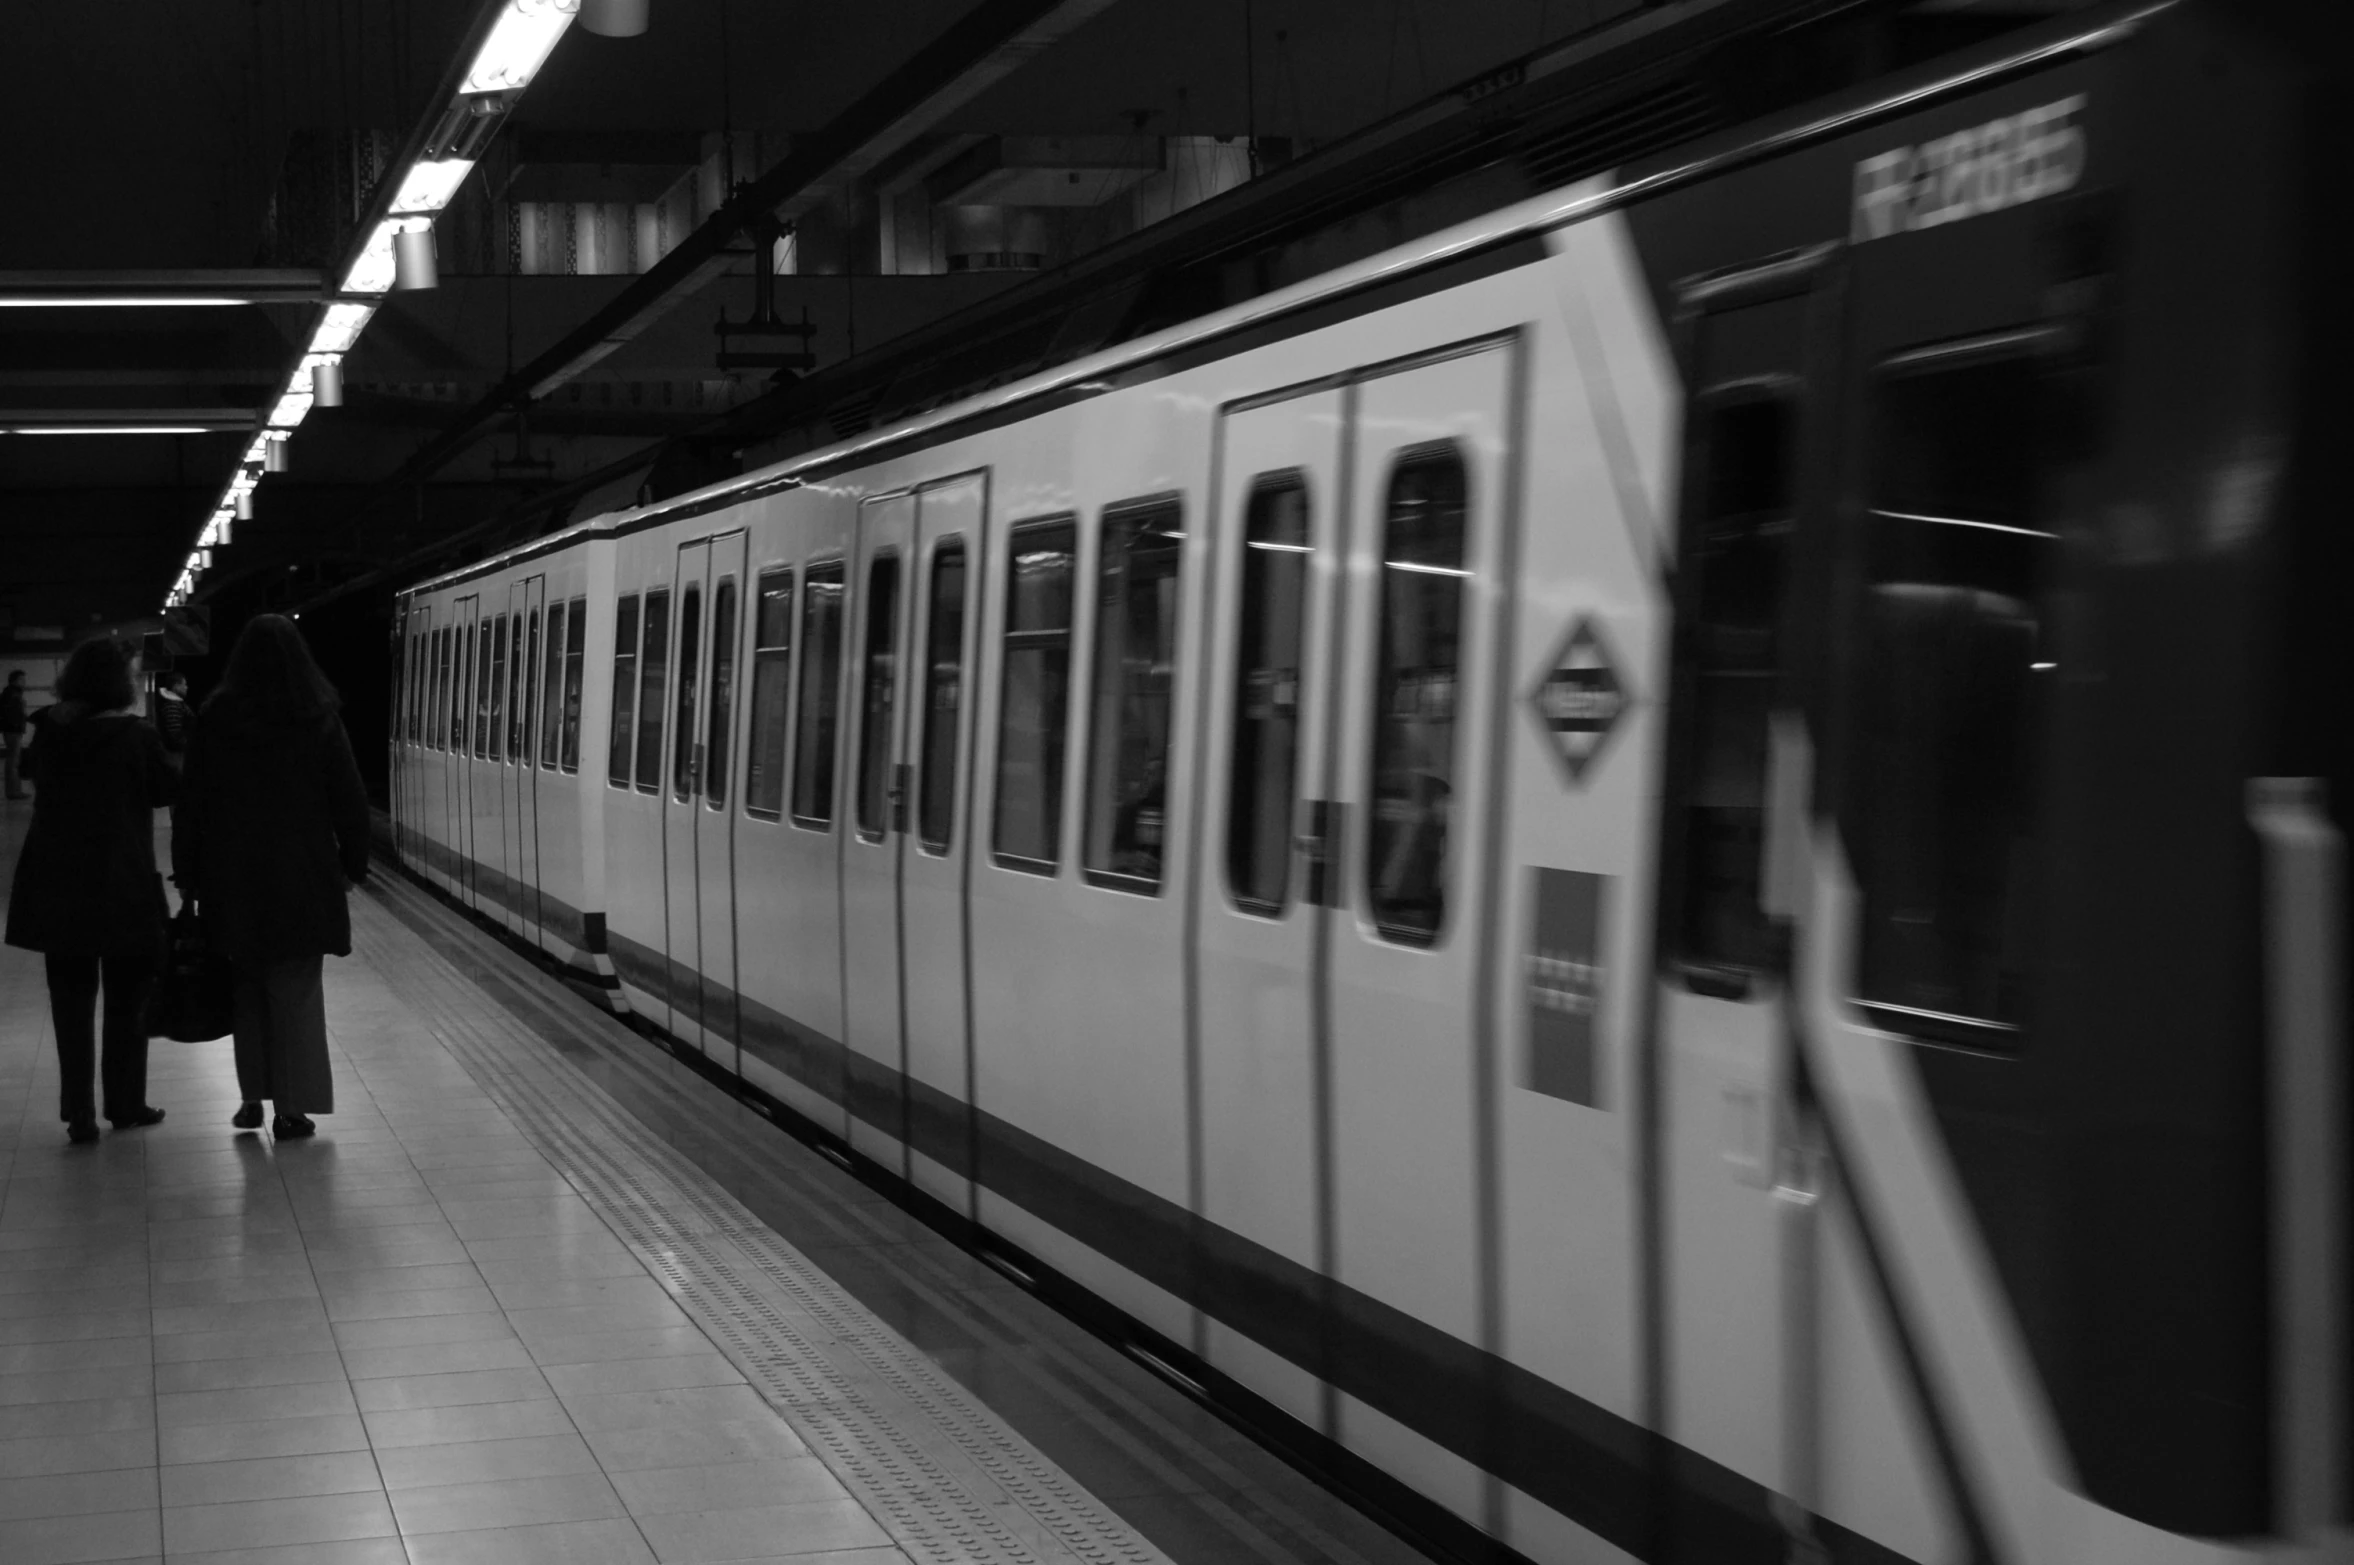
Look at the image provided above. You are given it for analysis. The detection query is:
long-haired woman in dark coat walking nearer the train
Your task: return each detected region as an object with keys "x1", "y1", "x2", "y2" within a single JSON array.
[{"x1": 172, "y1": 614, "x2": 367, "y2": 1139}]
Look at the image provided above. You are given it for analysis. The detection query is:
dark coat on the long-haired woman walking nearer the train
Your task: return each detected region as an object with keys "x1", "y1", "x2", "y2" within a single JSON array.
[{"x1": 172, "y1": 694, "x2": 367, "y2": 965}]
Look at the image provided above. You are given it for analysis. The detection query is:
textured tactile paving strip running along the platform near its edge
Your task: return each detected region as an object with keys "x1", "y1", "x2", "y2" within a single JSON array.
[{"x1": 353, "y1": 892, "x2": 1168, "y2": 1565}]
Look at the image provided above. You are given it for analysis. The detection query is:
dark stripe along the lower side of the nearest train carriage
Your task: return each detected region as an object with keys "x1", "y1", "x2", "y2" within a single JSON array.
[{"x1": 610, "y1": 934, "x2": 1904, "y2": 1565}]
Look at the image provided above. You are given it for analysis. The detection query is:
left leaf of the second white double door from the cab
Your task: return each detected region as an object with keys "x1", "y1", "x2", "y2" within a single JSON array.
[{"x1": 843, "y1": 492, "x2": 916, "y2": 1174}]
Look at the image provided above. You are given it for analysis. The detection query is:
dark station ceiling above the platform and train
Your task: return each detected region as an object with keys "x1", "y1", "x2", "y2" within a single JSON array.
[{"x1": 0, "y1": 0, "x2": 2062, "y2": 650}]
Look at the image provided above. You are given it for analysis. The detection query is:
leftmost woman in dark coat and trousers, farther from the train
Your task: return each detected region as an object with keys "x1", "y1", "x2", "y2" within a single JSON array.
[{"x1": 7, "y1": 640, "x2": 177, "y2": 1141}]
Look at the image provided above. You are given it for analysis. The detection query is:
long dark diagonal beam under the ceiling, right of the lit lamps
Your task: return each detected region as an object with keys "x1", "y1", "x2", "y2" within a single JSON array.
[{"x1": 371, "y1": 0, "x2": 1113, "y2": 485}]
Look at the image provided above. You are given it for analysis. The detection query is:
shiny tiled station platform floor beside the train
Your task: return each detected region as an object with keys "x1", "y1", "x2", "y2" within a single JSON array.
[{"x1": 0, "y1": 805, "x2": 1424, "y2": 1565}]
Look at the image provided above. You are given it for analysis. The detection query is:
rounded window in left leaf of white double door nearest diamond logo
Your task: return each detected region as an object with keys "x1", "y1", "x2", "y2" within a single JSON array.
[{"x1": 1226, "y1": 473, "x2": 1314, "y2": 915}]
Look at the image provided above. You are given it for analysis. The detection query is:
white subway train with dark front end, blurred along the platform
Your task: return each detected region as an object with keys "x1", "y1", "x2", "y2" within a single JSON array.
[{"x1": 393, "y1": 5, "x2": 2354, "y2": 1565}]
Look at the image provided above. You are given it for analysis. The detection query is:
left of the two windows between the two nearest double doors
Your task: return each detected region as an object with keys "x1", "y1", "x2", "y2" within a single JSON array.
[{"x1": 993, "y1": 520, "x2": 1078, "y2": 873}]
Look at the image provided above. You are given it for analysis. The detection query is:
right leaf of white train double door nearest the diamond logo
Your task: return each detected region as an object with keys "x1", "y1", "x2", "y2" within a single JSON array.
[{"x1": 1321, "y1": 341, "x2": 1514, "y2": 1487}]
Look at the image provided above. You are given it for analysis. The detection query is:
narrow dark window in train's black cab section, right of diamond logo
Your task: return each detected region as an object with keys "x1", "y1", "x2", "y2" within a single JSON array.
[{"x1": 1676, "y1": 388, "x2": 1796, "y2": 993}]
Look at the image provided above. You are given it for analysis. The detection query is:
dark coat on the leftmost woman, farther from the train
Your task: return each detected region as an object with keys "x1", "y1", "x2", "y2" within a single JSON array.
[{"x1": 7, "y1": 701, "x2": 177, "y2": 955}]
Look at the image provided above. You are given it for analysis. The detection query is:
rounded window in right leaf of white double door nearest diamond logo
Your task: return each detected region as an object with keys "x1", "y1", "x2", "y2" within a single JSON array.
[{"x1": 1365, "y1": 445, "x2": 1471, "y2": 946}]
